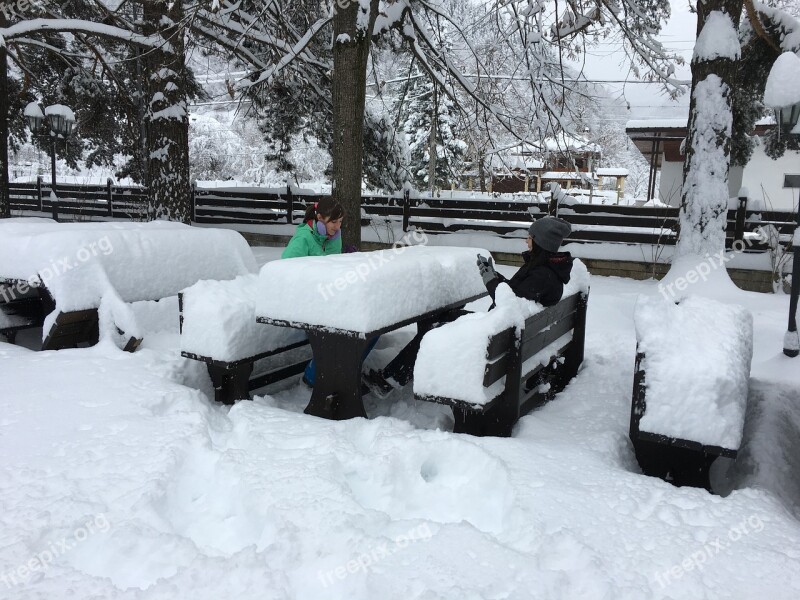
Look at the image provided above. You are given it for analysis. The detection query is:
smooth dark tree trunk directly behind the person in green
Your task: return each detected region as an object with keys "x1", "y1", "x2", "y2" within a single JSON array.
[{"x1": 332, "y1": 0, "x2": 378, "y2": 248}]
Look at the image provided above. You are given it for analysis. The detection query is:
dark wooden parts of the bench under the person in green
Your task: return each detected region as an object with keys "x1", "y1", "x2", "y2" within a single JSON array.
[{"x1": 178, "y1": 290, "x2": 308, "y2": 405}]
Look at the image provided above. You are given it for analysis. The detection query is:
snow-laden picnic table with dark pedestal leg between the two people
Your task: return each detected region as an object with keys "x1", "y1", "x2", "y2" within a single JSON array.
[{"x1": 256, "y1": 246, "x2": 488, "y2": 419}]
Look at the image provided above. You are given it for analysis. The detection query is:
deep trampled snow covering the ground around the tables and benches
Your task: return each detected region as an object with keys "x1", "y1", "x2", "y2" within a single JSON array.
[{"x1": 0, "y1": 255, "x2": 800, "y2": 600}]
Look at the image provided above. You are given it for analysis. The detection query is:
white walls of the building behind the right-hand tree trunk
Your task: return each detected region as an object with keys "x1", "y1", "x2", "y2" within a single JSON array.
[{"x1": 659, "y1": 145, "x2": 800, "y2": 211}]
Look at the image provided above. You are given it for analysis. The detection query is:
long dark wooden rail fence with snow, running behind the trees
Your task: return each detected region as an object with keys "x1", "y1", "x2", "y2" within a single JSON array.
[{"x1": 9, "y1": 178, "x2": 796, "y2": 251}]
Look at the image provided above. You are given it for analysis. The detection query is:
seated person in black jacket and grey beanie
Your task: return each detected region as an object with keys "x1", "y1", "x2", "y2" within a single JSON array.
[{"x1": 478, "y1": 217, "x2": 573, "y2": 306}]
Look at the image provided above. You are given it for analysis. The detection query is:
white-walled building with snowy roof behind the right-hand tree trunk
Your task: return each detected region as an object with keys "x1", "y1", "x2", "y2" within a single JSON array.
[{"x1": 625, "y1": 119, "x2": 800, "y2": 210}]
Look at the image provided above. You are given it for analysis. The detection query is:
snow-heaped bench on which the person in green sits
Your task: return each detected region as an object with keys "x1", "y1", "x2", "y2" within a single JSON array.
[{"x1": 178, "y1": 274, "x2": 310, "y2": 404}]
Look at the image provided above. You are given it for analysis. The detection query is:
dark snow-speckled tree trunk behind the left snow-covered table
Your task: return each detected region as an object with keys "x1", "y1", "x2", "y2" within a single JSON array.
[{"x1": 143, "y1": 0, "x2": 192, "y2": 223}]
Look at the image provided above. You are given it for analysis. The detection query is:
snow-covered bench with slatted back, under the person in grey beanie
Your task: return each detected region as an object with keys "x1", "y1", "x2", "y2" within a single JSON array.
[{"x1": 414, "y1": 261, "x2": 589, "y2": 437}]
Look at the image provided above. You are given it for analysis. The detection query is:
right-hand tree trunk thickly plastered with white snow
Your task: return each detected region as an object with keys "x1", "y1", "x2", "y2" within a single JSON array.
[{"x1": 676, "y1": 0, "x2": 742, "y2": 257}]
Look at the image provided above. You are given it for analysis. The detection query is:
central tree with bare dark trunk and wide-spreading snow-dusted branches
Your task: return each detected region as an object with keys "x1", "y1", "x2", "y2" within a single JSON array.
[{"x1": 203, "y1": 0, "x2": 680, "y2": 244}]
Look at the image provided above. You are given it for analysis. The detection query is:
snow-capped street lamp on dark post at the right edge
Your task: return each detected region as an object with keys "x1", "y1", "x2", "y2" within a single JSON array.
[{"x1": 764, "y1": 52, "x2": 800, "y2": 357}]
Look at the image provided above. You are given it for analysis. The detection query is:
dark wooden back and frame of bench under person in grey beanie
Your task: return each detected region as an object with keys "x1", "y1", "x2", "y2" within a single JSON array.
[{"x1": 414, "y1": 292, "x2": 589, "y2": 437}]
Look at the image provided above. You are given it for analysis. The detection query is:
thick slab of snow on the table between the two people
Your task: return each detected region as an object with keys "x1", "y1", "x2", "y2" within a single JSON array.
[{"x1": 256, "y1": 246, "x2": 488, "y2": 334}]
